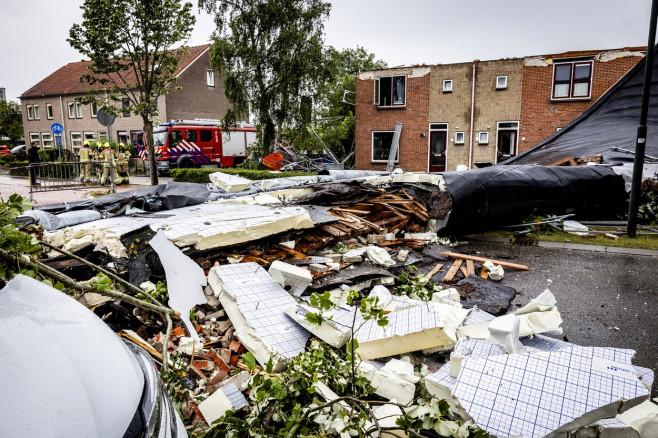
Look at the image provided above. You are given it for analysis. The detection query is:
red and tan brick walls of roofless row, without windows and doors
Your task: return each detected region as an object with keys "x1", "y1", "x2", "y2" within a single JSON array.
[{"x1": 355, "y1": 47, "x2": 643, "y2": 171}]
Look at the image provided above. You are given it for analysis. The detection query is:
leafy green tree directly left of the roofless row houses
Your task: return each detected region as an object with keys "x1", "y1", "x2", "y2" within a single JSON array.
[{"x1": 314, "y1": 46, "x2": 387, "y2": 156}]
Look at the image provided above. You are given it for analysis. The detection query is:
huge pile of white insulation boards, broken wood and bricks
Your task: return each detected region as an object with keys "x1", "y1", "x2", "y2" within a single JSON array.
[{"x1": 10, "y1": 169, "x2": 658, "y2": 438}]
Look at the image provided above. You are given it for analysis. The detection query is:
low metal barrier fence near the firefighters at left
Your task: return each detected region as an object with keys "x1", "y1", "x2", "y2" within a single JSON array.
[{"x1": 10, "y1": 161, "x2": 117, "y2": 197}]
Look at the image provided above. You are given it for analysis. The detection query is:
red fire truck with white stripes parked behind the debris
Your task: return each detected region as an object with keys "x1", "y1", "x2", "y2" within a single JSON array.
[{"x1": 135, "y1": 119, "x2": 256, "y2": 173}]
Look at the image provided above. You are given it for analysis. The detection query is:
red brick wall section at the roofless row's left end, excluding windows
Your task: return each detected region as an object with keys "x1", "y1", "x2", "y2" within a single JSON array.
[{"x1": 355, "y1": 67, "x2": 430, "y2": 172}]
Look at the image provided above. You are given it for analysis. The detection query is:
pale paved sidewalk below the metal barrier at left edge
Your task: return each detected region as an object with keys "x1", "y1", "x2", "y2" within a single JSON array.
[{"x1": 0, "y1": 175, "x2": 172, "y2": 205}]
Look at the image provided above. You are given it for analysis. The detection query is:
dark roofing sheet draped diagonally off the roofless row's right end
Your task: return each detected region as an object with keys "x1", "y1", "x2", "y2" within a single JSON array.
[{"x1": 503, "y1": 45, "x2": 658, "y2": 165}]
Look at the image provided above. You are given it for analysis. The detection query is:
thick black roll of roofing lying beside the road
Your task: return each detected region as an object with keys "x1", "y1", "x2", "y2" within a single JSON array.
[{"x1": 438, "y1": 166, "x2": 626, "y2": 234}]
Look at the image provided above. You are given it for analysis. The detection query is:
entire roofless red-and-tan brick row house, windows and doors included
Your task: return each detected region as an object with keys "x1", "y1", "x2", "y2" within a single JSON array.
[{"x1": 355, "y1": 48, "x2": 644, "y2": 172}]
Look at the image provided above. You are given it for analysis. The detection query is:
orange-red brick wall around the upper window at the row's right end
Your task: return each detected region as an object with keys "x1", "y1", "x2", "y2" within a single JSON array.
[{"x1": 519, "y1": 48, "x2": 643, "y2": 152}]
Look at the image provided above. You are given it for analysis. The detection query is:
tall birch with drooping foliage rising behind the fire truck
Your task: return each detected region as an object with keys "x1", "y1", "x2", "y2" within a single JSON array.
[{"x1": 199, "y1": 0, "x2": 331, "y2": 152}]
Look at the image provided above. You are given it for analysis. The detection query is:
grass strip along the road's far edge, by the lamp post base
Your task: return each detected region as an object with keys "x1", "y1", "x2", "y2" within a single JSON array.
[{"x1": 487, "y1": 227, "x2": 658, "y2": 250}]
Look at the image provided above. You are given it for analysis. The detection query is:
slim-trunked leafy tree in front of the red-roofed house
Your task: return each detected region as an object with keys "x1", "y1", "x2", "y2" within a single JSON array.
[{"x1": 68, "y1": 0, "x2": 195, "y2": 185}]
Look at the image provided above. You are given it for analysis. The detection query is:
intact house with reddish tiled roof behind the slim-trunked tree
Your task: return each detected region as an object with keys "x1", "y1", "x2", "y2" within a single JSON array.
[{"x1": 20, "y1": 45, "x2": 228, "y2": 152}]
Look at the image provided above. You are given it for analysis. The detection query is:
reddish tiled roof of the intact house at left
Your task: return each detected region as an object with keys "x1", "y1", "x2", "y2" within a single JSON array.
[{"x1": 20, "y1": 44, "x2": 210, "y2": 99}]
